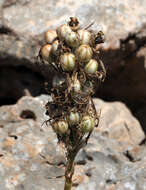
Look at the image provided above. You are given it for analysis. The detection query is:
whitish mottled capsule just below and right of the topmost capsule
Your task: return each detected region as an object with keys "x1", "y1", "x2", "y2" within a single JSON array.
[{"x1": 65, "y1": 32, "x2": 79, "y2": 47}]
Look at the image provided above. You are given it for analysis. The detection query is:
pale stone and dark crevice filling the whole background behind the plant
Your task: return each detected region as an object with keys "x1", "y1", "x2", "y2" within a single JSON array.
[{"x1": 0, "y1": 0, "x2": 146, "y2": 190}]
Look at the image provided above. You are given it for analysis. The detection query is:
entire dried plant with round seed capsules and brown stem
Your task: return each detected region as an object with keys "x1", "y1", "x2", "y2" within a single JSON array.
[{"x1": 38, "y1": 17, "x2": 106, "y2": 190}]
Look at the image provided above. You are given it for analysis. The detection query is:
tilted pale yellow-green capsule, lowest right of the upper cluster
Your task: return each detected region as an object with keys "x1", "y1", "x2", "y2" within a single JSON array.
[{"x1": 85, "y1": 59, "x2": 98, "y2": 74}]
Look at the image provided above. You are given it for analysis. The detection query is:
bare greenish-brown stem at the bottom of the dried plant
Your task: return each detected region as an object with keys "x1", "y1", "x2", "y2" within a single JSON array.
[{"x1": 64, "y1": 154, "x2": 75, "y2": 190}]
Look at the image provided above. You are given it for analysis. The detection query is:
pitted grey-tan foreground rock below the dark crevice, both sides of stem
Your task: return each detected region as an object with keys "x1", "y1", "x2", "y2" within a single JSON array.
[{"x1": 0, "y1": 95, "x2": 146, "y2": 190}]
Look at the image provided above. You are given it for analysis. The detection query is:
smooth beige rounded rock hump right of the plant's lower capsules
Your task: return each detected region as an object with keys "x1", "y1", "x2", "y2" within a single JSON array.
[{"x1": 94, "y1": 99, "x2": 145, "y2": 144}]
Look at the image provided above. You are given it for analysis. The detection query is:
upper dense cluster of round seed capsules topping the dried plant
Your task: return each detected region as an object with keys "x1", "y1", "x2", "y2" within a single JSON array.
[{"x1": 39, "y1": 17, "x2": 105, "y2": 76}]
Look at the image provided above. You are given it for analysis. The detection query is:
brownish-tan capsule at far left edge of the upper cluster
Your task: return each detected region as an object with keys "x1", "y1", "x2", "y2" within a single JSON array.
[{"x1": 40, "y1": 44, "x2": 52, "y2": 61}]
